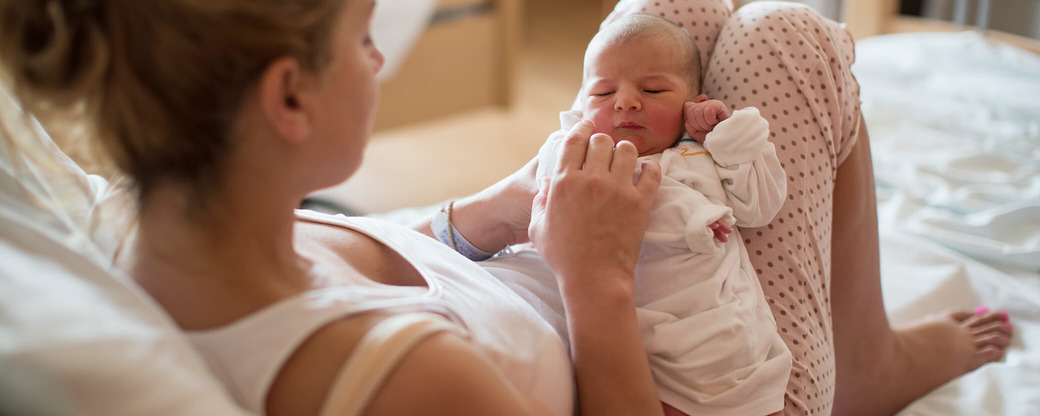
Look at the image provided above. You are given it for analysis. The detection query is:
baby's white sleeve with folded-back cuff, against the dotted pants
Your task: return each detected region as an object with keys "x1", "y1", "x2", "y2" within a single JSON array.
[{"x1": 704, "y1": 107, "x2": 787, "y2": 227}]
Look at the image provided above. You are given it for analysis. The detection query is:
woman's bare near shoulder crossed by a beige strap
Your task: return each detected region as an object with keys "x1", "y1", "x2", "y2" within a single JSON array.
[{"x1": 266, "y1": 313, "x2": 549, "y2": 416}]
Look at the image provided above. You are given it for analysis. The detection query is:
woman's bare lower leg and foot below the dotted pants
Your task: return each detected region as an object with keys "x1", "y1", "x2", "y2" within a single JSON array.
[{"x1": 831, "y1": 118, "x2": 1011, "y2": 415}]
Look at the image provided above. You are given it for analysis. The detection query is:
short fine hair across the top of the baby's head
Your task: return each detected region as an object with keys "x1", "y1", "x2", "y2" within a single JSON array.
[{"x1": 584, "y1": 14, "x2": 701, "y2": 98}]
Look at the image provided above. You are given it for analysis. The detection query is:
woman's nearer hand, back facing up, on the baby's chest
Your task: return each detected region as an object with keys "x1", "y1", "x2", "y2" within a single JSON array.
[{"x1": 528, "y1": 121, "x2": 660, "y2": 284}]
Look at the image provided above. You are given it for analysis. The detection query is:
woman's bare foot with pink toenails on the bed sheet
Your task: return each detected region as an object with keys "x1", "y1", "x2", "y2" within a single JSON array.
[{"x1": 882, "y1": 307, "x2": 1012, "y2": 413}]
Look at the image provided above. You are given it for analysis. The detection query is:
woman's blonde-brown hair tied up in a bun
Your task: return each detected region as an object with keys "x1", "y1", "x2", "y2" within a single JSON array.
[{"x1": 0, "y1": 0, "x2": 346, "y2": 198}]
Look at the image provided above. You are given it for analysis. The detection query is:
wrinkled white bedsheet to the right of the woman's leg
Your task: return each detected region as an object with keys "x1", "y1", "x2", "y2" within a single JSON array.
[{"x1": 853, "y1": 32, "x2": 1040, "y2": 415}]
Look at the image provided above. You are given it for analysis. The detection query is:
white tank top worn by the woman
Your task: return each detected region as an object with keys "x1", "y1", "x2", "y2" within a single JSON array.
[{"x1": 188, "y1": 210, "x2": 574, "y2": 415}]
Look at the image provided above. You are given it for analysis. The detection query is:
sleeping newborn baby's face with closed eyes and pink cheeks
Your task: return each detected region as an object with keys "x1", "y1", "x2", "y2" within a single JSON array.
[{"x1": 581, "y1": 38, "x2": 690, "y2": 156}]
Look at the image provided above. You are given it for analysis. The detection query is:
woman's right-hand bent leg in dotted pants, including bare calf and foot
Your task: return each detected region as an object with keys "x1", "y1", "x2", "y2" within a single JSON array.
[{"x1": 702, "y1": 2, "x2": 1010, "y2": 415}]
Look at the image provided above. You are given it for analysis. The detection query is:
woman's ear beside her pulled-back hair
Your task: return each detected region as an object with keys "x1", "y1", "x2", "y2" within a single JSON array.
[{"x1": 259, "y1": 57, "x2": 312, "y2": 144}]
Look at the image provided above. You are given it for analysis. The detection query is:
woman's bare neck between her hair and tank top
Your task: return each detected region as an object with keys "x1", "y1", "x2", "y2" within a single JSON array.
[{"x1": 128, "y1": 185, "x2": 309, "y2": 297}]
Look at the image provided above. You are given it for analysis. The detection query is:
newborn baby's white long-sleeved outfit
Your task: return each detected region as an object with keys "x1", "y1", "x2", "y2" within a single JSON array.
[{"x1": 528, "y1": 107, "x2": 791, "y2": 415}]
